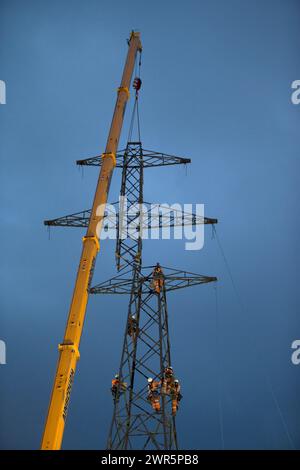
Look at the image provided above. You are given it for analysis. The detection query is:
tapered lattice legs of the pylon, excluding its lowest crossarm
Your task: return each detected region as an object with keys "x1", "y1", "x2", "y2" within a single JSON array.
[{"x1": 107, "y1": 268, "x2": 178, "y2": 450}]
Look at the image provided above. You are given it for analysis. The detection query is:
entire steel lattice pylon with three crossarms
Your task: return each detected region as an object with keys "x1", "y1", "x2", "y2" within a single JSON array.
[{"x1": 45, "y1": 142, "x2": 217, "y2": 449}]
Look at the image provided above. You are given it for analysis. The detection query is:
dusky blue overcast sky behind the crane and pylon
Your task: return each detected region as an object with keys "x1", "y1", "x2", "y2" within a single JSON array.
[{"x1": 0, "y1": 0, "x2": 300, "y2": 449}]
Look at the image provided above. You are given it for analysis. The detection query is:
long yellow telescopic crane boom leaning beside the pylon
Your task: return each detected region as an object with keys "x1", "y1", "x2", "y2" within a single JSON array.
[{"x1": 41, "y1": 31, "x2": 142, "y2": 450}]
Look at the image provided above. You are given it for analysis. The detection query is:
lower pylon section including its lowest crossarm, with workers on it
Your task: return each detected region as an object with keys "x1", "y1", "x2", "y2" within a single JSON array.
[{"x1": 90, "y1": 266, "x2": 216, "y2": 450}]
